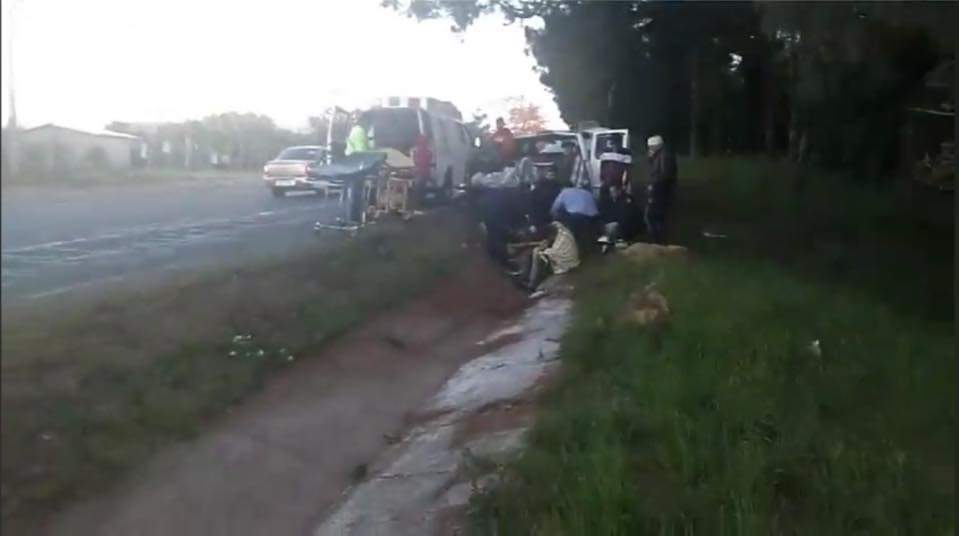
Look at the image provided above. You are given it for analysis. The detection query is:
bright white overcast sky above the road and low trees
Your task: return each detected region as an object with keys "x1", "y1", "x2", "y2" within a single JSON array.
[{"x1": 2, "y1": 0, "x2": 562, "y2": 132}]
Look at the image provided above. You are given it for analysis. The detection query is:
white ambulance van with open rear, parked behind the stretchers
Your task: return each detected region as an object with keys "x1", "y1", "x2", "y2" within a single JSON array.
[{"x1": 338, "y1": 97, "x2": 474, "y2": 196}]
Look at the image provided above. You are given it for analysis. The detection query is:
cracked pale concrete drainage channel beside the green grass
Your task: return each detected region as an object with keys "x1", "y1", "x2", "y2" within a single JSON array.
[{"x1": 315, "y1": 297, "x2": 571, "y2": 536}]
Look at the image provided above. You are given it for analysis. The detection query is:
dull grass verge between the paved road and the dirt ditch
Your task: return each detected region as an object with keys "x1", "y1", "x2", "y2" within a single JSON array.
[{"x1": 2, "y1": 214, "x2": 464, "y2": 533}]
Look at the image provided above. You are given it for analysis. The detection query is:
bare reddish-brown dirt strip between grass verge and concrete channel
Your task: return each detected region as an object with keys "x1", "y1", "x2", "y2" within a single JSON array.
[{"x1": 39, "y1": 260, "x2": 525, "y2": 535}]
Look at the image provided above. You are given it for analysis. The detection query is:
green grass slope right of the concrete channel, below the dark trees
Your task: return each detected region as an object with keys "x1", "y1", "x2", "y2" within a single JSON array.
[{"x1": 472, "y1": 160, "x2": 956, "y2": 536}]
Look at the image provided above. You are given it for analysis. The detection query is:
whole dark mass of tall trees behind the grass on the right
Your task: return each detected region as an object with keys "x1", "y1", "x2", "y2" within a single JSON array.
[{"x1": 383, "y1": 0, "x2": 959, "y2": 180}]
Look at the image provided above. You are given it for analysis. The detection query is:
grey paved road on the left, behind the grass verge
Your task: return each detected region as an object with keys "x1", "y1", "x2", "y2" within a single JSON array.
[{"x1": 2, "y1": 177, "x2": 337, "y2": 305}]
